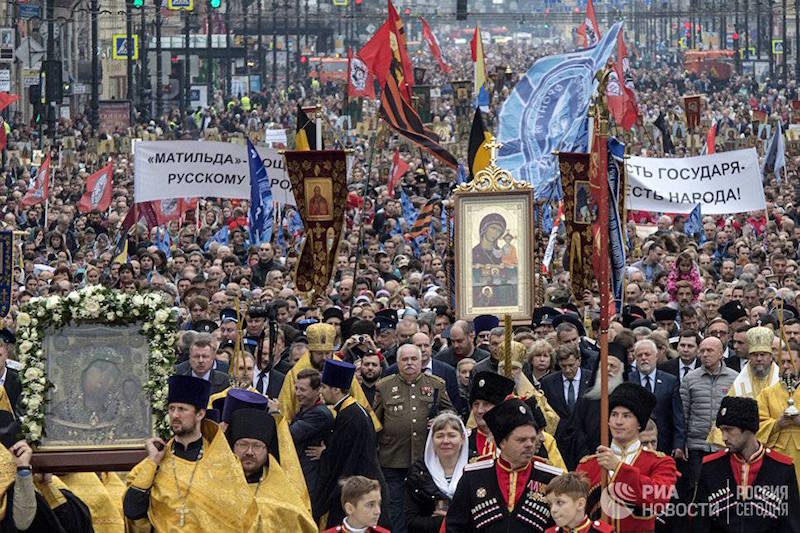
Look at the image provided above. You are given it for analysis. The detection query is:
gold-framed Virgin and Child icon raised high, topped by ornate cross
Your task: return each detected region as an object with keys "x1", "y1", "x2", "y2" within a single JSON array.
[{"x1": 454, "y1": 154, "x2": 535, "y2": 324}]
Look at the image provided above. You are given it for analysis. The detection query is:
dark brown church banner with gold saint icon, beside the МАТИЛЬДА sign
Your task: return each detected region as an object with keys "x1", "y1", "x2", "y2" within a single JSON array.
[{"x1": 284, "y1": 150, "x2": 347, "y2": 295}]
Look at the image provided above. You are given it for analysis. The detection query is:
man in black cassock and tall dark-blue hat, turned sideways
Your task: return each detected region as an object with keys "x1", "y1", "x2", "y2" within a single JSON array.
[{"x1": 309, "y1": 359, "x2": 389, "y2": 525}]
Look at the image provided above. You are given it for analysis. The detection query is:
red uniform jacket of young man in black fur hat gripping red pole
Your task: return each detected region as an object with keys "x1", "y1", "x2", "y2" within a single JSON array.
[{"x1": 576, "y1": 448, "x2": 678, "y2": 533}]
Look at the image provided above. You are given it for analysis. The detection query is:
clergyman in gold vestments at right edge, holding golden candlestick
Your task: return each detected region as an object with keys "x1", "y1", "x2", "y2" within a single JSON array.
[{"x1": 756, "y1": 345, "x2": 800, "y2": 486}]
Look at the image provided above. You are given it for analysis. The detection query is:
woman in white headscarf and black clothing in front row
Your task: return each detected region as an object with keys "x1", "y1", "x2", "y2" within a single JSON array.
[{"x1": 405, "y1": 411, "x2": 469, "y2": 533}]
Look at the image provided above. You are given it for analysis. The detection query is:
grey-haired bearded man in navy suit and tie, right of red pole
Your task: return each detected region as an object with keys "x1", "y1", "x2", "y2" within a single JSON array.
[{"x1": 628, "y1": 339, "x2": 686, "y2": 459}]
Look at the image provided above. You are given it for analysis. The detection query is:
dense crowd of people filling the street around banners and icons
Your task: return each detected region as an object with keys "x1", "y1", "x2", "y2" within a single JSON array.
[{"x1": 0, "y1": 23, "x2": 800, "y2": 533}]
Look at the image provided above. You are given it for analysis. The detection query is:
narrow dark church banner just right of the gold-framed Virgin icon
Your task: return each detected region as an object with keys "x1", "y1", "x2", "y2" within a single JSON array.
[{"x1": 558, "y1": 152, "x2": 597, "y2": 300}]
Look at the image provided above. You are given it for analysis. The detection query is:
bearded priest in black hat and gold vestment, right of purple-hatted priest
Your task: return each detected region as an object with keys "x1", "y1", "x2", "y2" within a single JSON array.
[{"x1": 227, "y1": 408, "x2": 317, "y2": 533}]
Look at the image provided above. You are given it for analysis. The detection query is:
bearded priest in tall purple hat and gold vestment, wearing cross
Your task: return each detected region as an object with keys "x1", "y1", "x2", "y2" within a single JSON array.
[{"x1": 123, "y1": 376, "x2": 258, "y2": 532}]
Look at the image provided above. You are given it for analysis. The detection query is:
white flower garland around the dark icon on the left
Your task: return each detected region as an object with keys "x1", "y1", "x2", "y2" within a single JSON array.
[{"x1": 16, "y1": 285, "x2": 177, "y2": 444}]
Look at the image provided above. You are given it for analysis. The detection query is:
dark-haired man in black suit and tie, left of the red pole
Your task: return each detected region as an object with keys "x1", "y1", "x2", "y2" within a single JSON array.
[{"x1": 540, "y1": 343, "x2": 592, "y2": 425}]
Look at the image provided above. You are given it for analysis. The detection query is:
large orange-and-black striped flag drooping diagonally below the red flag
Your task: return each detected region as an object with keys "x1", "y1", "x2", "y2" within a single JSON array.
[{"x1": 380, "y1": 72, "x2": 458, "y2": 169}]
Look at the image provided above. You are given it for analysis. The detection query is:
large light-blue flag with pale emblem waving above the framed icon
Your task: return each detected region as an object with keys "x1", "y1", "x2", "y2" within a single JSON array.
[{"x1": 497, "y1": 22, "x2": 622, "y2": 200}]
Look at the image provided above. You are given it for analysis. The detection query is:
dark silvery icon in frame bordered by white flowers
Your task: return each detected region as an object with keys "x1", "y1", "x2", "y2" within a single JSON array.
[{"x1": 15, "y1": 286, "x2": 177, "y2": 471}]
